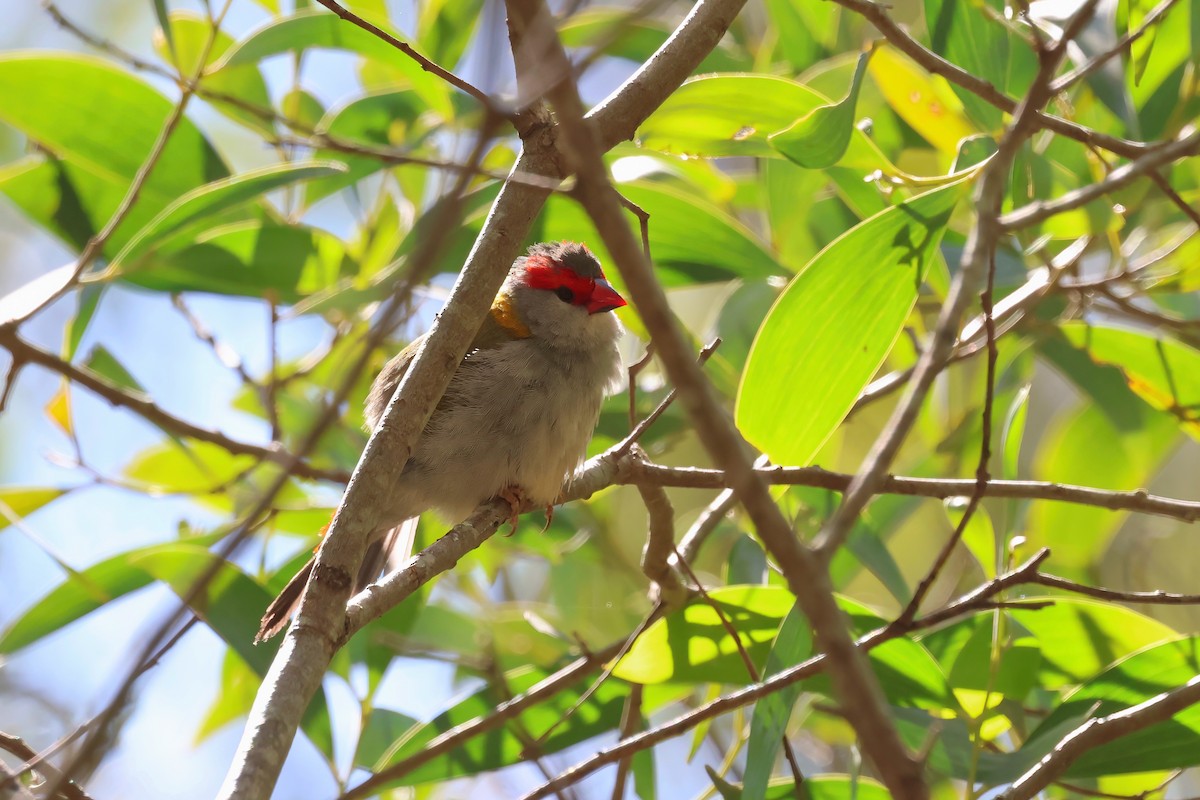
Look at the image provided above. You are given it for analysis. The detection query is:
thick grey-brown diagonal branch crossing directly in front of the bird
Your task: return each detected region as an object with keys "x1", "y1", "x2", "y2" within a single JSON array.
[{"x1": 218, "y1": 0, "x2": 744, "y2": 800}]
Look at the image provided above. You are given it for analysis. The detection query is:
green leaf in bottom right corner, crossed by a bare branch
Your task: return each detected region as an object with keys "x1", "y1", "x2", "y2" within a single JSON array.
[{"x1": 1026, "y1": 636, "x2": 1200, "y2": 777}]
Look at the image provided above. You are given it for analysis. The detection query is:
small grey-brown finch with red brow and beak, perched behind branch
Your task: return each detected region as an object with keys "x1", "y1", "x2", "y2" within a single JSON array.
[{"x1": 254, "y1": 241, "x2": 626, "y2": 644}]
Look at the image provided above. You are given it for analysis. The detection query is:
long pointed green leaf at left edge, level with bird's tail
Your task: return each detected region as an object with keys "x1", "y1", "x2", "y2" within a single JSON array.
[{"x1": 0, "y1": 534, "x2": 223, "y2": 652}]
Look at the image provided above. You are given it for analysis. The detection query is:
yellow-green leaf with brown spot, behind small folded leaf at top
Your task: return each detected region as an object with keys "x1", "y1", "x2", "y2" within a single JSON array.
[{"x1": 637, "y1": 73, "x2": 894, "y2": 172}]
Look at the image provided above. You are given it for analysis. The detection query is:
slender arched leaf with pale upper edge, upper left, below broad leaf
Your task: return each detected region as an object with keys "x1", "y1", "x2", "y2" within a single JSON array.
[{"x1": 112, "y1": 161, "x2": 346, "y2": 276}]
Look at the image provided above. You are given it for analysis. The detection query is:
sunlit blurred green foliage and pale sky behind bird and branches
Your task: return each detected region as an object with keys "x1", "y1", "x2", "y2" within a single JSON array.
[{"x1": 0, "y1": 0, "x2": 1200, "y2": 798}]
